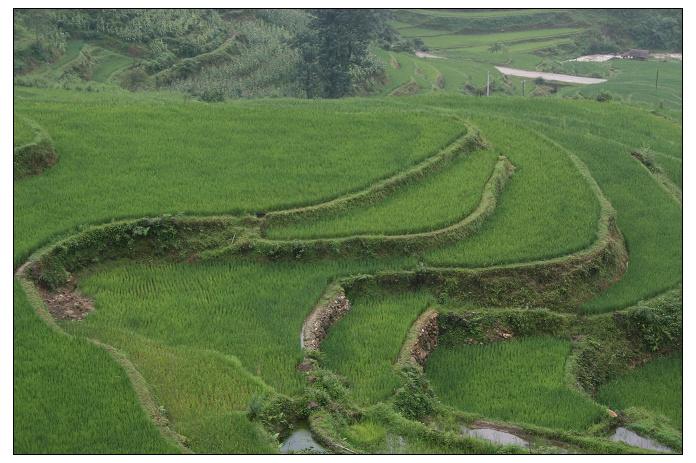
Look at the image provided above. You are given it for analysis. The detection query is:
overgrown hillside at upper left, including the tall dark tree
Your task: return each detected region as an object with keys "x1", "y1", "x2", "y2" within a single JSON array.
[{"x1": 14, "y1": 9, "x2": 394, "y2": 102}]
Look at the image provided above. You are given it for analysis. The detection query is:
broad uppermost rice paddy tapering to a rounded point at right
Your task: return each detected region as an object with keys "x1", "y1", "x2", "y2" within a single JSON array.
[{"x1": 14, "y1": 89, "x2": 463, "y2": 262}]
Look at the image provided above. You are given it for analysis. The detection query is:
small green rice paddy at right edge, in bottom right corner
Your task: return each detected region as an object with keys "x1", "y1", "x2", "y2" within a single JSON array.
[{"x1": 597, "y1": 355, "x2": 683, "y2": 429}]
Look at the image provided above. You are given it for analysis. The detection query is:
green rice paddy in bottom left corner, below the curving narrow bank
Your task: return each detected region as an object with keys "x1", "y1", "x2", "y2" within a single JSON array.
[{"x1": 13, "y1": 282, "x2": 178, "y2": 453}]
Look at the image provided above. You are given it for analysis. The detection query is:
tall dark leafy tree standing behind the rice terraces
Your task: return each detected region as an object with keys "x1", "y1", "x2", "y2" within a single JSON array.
[{"x1": 295, "y1": 9, "x2": 385, "y2": 98}]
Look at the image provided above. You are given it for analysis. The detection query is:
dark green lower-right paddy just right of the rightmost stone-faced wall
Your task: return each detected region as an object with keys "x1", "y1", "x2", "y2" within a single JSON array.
[{"x1": 426, "y1": 338, "x2": 605, "y2": 431}]
